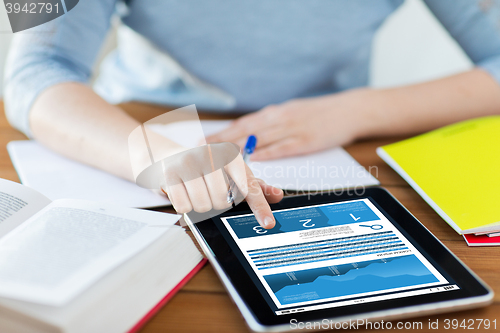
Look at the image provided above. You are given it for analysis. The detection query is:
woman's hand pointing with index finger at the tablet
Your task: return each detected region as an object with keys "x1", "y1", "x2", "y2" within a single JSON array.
[{"x1": 162, "y1": 142, "x2": 283, "y2": 229}]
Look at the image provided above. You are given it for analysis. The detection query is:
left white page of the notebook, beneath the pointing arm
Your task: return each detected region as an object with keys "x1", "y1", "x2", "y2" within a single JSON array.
[{"x1": 7, "y1": 140, "x2": 170, "y2": 208}]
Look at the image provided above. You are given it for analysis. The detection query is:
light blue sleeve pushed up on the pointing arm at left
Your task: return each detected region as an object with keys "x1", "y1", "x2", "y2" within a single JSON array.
[{"x1": 4, "y1": 0, "x2": 116, "y2": 137}]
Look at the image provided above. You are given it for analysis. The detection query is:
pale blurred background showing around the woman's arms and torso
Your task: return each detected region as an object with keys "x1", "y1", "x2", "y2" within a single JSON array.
[{"x1": 0, "y1": 0, "x2": 472, "y2": 98}]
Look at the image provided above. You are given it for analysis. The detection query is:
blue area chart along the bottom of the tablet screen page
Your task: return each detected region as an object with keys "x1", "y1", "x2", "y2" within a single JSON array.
[{"x1": 264, "y1": 255, "x2": 438, "y2": 304}]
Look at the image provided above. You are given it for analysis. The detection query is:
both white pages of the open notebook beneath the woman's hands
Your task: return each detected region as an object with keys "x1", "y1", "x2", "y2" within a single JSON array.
[{"x1": 7, "y1": 121, "x2": 379, "y2": 208}]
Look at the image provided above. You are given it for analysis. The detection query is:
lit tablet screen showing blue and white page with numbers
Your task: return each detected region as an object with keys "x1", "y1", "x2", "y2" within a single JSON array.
[{"x1": 220, "y1": 198, "x2": 460, "y2": 316}]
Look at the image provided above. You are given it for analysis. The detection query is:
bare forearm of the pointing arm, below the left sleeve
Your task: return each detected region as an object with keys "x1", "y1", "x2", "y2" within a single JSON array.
[{"x1": 29, "y1": 83, "x2": 180, "y2": 181}]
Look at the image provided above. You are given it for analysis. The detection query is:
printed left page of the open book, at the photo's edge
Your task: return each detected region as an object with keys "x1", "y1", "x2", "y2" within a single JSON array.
[{"x1": 0, "y1": 178, "x2": 50, "y2": 238}]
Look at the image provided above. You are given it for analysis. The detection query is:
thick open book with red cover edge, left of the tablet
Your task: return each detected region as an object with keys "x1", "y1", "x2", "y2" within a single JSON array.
[{"x1": 0, "y1": 179, "x2": 204, "y2": 333}]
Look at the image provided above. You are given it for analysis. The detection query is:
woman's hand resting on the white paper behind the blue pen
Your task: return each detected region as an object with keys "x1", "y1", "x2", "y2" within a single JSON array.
[{"x1": 207, "y1": 89, "x2": 376, "y2": 161}]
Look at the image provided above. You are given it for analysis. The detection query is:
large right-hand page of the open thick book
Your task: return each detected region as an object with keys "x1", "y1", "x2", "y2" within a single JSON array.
[{"x1": 0, "y1": 200, "x2": 180, "y2": 306}]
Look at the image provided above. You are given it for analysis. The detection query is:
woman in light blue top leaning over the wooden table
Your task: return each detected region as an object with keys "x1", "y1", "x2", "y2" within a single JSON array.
[{"x1": 5, "y1": 0, "x2": 500, "y2": 228}]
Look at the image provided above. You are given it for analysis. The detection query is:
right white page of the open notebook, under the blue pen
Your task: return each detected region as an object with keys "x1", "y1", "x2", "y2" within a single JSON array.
[{"x1": 148, "y1": 120, "x2": 379, "y2": 192}]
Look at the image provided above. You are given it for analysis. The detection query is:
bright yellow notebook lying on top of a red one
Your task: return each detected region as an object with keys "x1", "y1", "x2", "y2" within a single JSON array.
[{"x1": 377, "y1": 116, "x2": 500, "y2": 234}]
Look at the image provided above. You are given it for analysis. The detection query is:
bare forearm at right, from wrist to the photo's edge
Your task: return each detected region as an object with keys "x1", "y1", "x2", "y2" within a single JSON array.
[{"x1": 360, "y1": 69, "x2": 500, "y2": 137}]
